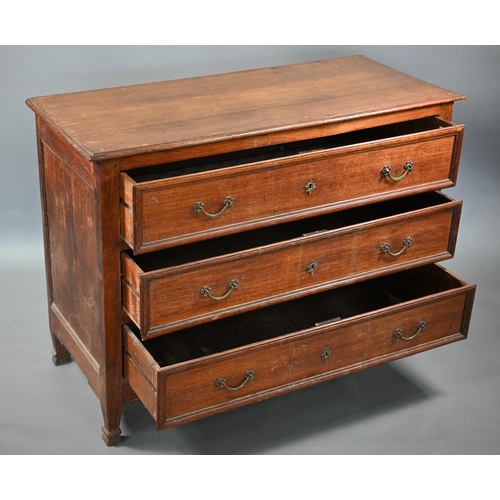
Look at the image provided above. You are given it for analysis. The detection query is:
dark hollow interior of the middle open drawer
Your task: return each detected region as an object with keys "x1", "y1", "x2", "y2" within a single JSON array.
[{"x1": 126, "y1": 192, "x2": 450, "y2": 272}]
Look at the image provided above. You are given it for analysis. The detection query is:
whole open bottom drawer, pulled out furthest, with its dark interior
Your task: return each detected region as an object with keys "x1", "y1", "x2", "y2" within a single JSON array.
[{"x1": 124, "y1": 265, "x2": 475, "y2": 430}]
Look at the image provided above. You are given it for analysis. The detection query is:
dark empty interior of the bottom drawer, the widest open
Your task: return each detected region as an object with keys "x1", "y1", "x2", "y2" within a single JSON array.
[{"x1": 130, "y1": 265, "x2": 464, "y2": 367}]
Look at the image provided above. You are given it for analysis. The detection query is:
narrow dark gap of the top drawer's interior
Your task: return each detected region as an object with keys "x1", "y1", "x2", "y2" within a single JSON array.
[{"x1": 127, "y1": 117, "x2": 452, "y2": 183}]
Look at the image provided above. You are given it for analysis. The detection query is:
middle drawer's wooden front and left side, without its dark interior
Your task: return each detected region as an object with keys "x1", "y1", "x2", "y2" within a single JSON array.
[{"x1": 122, "y1": 193, "x2": 461, "y2": 338}]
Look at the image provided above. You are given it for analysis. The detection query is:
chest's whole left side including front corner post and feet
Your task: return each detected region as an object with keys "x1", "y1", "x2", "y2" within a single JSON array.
[{"x1": 38, "y1": 124, "x2": 125, "y2": 445}]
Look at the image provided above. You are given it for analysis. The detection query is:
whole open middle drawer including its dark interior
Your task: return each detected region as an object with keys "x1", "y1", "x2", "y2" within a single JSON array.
[{"x1": 122, "y1": 192, "x2": 461, "y2": 338}]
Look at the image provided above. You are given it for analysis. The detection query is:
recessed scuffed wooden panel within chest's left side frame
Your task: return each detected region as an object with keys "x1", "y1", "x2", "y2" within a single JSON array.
[{"x1": 44, "y1": 146, "x2": 102, "y2": 366}]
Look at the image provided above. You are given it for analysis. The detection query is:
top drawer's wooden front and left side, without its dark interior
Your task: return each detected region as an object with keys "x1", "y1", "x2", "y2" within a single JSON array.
[{"x1": 121, "y1": 126, "x2": 462, "y2": 253}]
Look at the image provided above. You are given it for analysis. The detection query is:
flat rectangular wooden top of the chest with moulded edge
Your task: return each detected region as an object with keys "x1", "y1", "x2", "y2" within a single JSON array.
[{"x1": 27, "y1": 56, "x2": 465, "y2": 160}]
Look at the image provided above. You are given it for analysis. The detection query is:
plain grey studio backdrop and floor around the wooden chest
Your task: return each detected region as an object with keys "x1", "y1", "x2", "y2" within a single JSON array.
[{"x1": 0, "y1": 46, "x2": 500, "y2": 455}]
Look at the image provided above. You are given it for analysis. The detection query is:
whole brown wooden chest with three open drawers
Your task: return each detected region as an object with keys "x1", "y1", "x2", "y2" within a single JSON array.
[{"x1": 27, "y1": 56, "x2": 475, "y2": 445}]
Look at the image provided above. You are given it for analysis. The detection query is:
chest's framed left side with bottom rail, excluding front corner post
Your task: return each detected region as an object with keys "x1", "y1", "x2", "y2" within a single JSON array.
[{"x1": 37, "y1": 136, "x2": 105, "y2": 397}]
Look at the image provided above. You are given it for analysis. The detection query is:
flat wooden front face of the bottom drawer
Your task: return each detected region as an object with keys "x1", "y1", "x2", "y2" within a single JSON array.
[{"x1": 157, "y1": 280, "x2": 467, "y2": 428}]
